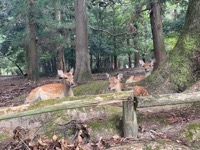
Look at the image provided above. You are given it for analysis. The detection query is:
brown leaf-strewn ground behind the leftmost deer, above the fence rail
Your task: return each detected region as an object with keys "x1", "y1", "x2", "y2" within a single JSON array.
[{"x1": 0, "y1": 76, "x2": 59, "y2": 107}]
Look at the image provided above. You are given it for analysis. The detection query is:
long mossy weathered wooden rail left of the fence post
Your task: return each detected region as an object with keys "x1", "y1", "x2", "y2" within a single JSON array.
[{"x1": 0, "y1": 91, "x2": 132, "y2": 120}]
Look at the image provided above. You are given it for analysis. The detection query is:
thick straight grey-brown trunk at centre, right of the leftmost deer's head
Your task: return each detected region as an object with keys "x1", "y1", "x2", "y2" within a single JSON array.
[{"x1": 74, "y1": 0, "x2": 92, "y2": 82}]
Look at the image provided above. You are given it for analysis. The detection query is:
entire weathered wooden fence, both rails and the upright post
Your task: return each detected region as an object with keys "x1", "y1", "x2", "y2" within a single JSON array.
[{"x1": 0, "y1": 91, "x2": 200, "y2": 137}]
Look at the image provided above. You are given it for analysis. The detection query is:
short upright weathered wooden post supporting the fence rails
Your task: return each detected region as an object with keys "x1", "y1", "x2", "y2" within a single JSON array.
[{"x1": 123, "y1": 95, "x2": 138, "y2": 138}]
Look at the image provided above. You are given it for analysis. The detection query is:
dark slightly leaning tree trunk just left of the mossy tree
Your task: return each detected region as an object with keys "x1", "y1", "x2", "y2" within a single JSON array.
[{"x1": 150, "y1": 2, "x2": 166, "y2": 69}]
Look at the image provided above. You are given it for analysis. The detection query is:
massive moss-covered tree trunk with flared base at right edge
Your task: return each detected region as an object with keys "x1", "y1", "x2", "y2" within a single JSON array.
[{"x1": 147, "y1": 0, "x2": 200, "y2": 93}]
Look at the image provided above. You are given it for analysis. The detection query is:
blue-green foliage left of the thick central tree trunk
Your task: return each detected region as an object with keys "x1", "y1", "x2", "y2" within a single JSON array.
[{"x1": 0, "y1": 0, "x2": 75, "y2": 75}]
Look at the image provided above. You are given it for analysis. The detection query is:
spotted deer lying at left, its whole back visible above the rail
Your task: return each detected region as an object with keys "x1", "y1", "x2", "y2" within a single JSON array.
[{"x1": 25, "y1": 68, "x2": 75, "y2": 103}]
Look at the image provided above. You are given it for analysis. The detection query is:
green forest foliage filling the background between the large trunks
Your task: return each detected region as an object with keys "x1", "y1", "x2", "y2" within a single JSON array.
[{"x1": 0, "y1": 0, "x2": 188, "y2": 72}]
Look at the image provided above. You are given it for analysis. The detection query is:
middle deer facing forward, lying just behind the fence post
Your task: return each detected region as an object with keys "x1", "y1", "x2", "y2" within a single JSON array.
[{"x1": 106, "y1": 73, "x2": 149, "y2": 96}]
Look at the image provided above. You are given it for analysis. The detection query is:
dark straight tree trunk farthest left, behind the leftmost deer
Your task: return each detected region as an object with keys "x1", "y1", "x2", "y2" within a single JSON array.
[{"x1": 26, "y1": 0, "x2": 39, "y2": 82}]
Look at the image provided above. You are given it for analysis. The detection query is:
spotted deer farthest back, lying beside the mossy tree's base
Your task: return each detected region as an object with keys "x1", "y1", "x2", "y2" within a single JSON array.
[{"x1": 126, "y1": 60, "x2": 154, "y2": 83}]
